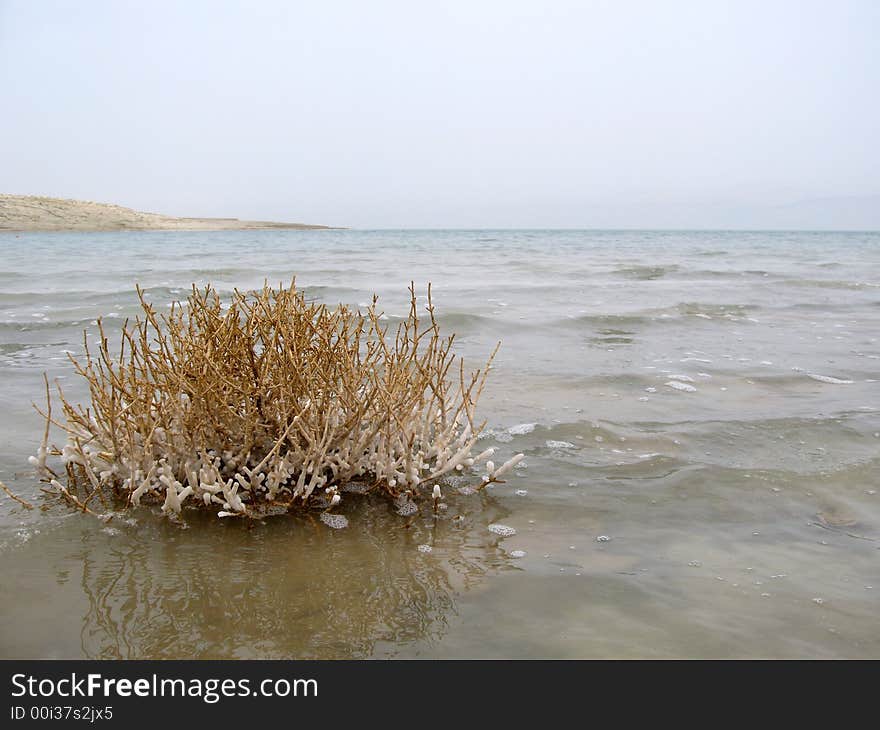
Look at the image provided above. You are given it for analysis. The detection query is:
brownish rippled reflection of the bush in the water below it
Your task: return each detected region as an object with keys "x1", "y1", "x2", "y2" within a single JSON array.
[{"x1": 81, "y1": 496, "x2": 508, "y2": 659}]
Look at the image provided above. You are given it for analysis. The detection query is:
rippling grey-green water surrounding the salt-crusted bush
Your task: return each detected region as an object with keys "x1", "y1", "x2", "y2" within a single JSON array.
[{"x1": 0, "y1": 231, "x2": 880, "y2": 658}]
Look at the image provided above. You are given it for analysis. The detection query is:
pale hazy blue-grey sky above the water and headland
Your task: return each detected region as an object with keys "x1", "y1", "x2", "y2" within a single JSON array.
[{"x1": 0, "y1": 0, "x2": 880, "y2": 227}]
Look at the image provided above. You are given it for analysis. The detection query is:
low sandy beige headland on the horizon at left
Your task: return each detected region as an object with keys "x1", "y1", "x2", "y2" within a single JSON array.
[{"x1": 0, "y1": 194, "x2": 331, "y2": 231}]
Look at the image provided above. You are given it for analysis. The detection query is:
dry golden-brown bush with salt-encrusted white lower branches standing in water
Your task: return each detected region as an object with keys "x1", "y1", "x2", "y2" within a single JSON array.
[{"x1": 31, "y1": 283, "x2": 522, "y2": 526}]
